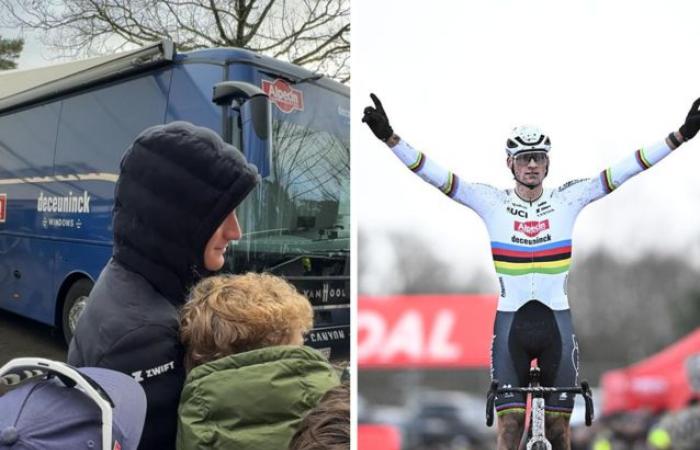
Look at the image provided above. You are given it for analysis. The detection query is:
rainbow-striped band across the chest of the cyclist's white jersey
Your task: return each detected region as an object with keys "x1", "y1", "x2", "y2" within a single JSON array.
[{"x1": 491, "y1": 239, "x2": 571, "y2": 276}]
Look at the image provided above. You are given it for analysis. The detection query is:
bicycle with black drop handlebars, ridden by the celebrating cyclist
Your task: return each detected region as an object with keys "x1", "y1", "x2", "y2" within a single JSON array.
[{"x1": 486, "y1": 367, "x2": 594, "y2": 450}]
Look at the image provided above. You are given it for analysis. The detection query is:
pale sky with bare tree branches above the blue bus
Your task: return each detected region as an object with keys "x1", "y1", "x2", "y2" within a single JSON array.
[{"x1": 0, "y1": 0, "x2": 350, "y2": 82}]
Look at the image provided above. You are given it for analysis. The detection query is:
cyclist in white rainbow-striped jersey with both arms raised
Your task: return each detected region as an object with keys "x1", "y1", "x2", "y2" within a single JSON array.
[{"x1": 362, "y1": 94, "x2": 700, "y2": 450}]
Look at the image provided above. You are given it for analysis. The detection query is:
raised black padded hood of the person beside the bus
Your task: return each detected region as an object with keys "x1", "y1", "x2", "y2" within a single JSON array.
[{"x1": 112, "y1": 122, "x2": 259, "y2": 305}]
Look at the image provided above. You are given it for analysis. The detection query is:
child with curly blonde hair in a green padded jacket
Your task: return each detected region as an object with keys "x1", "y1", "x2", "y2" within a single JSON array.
[{"x1": 177, "y1": 273, "x2": 339, "y2": 450}]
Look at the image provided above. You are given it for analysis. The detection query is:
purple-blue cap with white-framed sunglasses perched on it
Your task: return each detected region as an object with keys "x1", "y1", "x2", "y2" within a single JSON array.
[{"x1": 0, "y1": 358, "x2": 146, "y2": 450}]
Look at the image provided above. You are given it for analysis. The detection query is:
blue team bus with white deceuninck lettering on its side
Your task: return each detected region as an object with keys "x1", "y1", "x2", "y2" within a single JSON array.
[{"x1": 0, "y1": 41, "x2": 350, "y2": 359}]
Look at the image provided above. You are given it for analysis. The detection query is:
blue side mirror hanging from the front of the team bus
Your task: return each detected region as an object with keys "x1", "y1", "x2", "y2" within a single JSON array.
[{"x1": 212, "y1": 81, "x2": 272, "y2": 178}]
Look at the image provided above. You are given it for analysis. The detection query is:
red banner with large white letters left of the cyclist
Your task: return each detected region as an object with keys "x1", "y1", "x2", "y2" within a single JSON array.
[{"x1": 357, "y1": 295, "x2": 497, "y2": 369}]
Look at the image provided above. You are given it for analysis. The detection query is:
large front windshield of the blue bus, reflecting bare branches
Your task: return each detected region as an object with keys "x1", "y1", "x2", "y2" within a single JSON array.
[{"x1": 226, "y1": 75, "x2": 350, "y2": 276}]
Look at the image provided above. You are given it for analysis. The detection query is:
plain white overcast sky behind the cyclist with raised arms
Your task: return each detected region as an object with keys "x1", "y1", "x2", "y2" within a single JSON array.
[{"x1": 352, "y1": 0, "x2": 700, "y2": 278}]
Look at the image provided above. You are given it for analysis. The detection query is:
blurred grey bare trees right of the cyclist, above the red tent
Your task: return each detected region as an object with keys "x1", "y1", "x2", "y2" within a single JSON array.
[{"x1": 568, "y1": 250, "x2": 700, "y2": 370}]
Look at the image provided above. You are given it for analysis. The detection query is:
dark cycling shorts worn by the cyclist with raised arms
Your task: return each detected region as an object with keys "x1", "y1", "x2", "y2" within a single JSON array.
[{"x1": 491, "y1": 300, "x2": 578, "y2": 414}]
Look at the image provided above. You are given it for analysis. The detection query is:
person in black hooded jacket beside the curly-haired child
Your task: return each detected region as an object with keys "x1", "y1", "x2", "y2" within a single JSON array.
[{"x1": 68, "y1": 122, "x2": 259, "y2": 450}]
